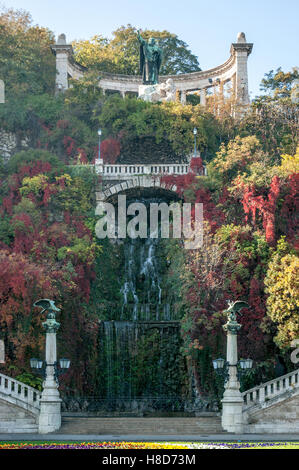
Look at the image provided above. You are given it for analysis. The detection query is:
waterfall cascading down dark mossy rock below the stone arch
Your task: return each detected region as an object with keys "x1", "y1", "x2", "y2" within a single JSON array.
[{"x1": 101, "y1": 199, "x2": 186, "y2": 399}]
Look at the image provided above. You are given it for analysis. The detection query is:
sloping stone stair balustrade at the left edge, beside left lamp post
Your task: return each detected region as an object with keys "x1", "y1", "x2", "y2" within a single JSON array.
[{"x1": 0, "y1": 374, "x2": 41, "y2": 414}]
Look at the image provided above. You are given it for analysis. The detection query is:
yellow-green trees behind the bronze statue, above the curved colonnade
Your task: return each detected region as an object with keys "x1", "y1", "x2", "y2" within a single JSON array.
[{"x1": 73, "y1": 24, "x2": 200, "y2": 75}]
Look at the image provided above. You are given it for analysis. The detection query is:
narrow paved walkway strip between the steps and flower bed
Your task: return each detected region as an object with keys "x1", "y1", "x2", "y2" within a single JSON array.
[{"x1": 0, "y1": 433, "x2": 299, "y2": 442}]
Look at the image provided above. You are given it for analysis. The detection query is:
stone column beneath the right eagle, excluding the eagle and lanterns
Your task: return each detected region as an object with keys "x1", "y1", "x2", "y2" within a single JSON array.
[{"x1": 221, "y1": 318, "x2": 243, "y2": 433}]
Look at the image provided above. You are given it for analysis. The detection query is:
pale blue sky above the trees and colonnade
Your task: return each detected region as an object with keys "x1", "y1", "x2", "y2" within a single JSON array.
[{"x1": 0, "y1": 0, "x2": 299, "y2": 98}]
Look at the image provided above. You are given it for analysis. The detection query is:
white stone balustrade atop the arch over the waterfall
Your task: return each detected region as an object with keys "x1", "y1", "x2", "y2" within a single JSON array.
[{"x1": 95, "y1": 162, "x2": 190, "y2": 178}]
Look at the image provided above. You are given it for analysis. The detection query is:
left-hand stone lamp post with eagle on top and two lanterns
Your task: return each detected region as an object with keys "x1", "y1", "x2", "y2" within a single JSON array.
[{"x1": 30, "y1": 299, "x2": 69, "y2": 434}]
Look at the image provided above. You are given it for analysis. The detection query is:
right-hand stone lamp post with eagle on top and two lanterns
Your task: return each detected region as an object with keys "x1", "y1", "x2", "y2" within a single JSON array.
[{"x1": 213, "y1": 301, "x2": 252, "y2": 433}]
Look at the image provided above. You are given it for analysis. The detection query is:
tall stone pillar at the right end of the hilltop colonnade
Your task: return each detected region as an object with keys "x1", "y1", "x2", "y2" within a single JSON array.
[{"x1": 231, "y1": 33, "x2": 253, "y2": 105}]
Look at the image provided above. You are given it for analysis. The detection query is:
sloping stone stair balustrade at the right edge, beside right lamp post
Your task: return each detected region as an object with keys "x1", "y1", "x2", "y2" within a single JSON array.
[{"x1": 242, "y1": 369, "x2": 299, "y2": 411}]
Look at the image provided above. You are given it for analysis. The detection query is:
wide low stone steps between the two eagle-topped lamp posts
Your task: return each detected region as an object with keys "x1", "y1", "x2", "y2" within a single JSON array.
[{"x1": 59, "y1": 416, "x2": 223, "y2": 436}]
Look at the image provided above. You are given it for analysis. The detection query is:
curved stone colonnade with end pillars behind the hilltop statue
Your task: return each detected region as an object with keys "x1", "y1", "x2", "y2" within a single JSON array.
[{"x1": 51, "y1": 33, "x2": 253, "y2": 106}]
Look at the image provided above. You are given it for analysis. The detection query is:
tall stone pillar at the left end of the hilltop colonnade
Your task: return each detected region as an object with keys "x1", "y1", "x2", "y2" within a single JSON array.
[{"x1": 51, "y1": 34, "x2": 73, "y2": 92}]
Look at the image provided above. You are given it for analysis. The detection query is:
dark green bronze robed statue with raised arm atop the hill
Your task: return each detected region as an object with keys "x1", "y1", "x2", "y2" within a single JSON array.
[{"x1": 137, "y1": 31, "x2": 163, "y2": 85}]
